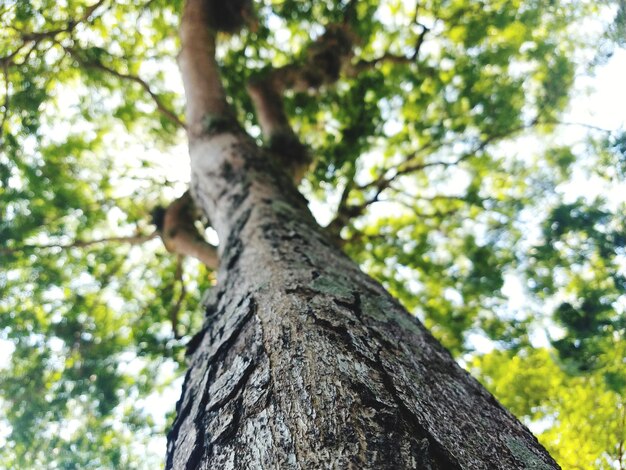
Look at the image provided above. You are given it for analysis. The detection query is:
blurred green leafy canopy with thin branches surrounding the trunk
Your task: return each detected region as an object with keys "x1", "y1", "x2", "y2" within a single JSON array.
[{"x1": 0, "y1": 0, "x2": 626, "y2": 469}]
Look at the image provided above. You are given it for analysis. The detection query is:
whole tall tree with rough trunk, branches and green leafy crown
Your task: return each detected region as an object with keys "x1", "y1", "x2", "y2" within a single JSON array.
[{"x1": 0, "y1": 0, "x2": 624, "y2": 469}]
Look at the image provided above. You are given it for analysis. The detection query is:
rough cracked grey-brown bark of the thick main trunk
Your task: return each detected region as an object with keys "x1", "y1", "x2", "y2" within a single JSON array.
[{"x1": 166, "y1": 0, "x2": 558, "y2": 470}]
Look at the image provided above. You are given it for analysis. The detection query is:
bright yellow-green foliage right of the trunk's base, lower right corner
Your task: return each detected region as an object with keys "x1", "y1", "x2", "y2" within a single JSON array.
[{"x1": 472, "y1": 348, "x2": 626, "y2": 470}]
